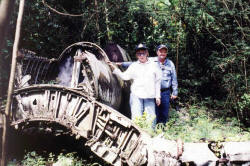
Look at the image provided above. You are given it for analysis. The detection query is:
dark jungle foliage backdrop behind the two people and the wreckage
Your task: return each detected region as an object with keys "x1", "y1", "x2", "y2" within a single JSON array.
[{"x1": 0, "y1": 0, "x2": 250, "y2": 125}]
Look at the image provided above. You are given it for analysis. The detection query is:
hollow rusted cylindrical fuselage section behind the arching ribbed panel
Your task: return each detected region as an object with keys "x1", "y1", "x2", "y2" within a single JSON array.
[{"x1": 17, "y1": 42, "x2": 123, "y2": 110}]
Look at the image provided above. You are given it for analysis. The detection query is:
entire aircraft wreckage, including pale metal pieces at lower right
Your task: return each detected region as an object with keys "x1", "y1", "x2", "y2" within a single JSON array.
[{"x1": 3, "y1": 42, "x2": 250, "y2": 166}]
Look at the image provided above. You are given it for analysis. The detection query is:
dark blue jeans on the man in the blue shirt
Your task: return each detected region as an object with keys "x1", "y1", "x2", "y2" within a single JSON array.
[{"x1": 156, "y1": 90, "x2": 170, "y2": 124}]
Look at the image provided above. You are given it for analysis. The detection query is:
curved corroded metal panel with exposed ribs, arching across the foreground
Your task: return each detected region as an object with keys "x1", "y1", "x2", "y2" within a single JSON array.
[{"x1": 11, "y1": 85, "x2": 148, "y2": 165}]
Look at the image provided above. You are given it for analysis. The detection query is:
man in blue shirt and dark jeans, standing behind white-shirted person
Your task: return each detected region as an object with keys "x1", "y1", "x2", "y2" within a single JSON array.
[{"x1": 116, "y1": 44, "x2": 178, "y2": 124}]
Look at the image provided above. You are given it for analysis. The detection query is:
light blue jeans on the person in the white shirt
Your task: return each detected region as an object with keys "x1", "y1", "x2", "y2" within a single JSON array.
[{"x1": 130, "y1": 93, "x2": 156, "y2": 128}]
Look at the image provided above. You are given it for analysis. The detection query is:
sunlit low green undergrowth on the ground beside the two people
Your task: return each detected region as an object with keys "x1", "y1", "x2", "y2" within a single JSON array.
[{"x1": 136, "y1": 105, "x2": 250, "y2": 142}]
